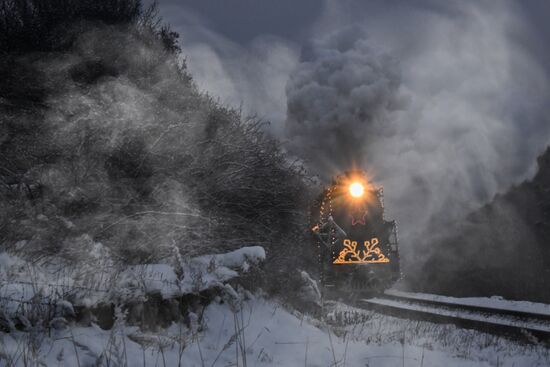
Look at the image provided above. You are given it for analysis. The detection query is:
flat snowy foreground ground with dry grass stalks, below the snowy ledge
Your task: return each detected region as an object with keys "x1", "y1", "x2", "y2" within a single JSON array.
[{"x1": 0, "y1": 297, "x2": 550, "y2": 367}]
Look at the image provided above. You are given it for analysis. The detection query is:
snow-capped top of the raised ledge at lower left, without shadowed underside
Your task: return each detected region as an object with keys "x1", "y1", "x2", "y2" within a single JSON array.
[{"x1": 0, "y1": 243, "x2": 265, "y2": 315}]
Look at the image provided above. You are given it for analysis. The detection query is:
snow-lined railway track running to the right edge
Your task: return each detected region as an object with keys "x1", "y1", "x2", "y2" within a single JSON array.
[{"x1": 359, "y1": 292, "x2": 550, "y2": 344}]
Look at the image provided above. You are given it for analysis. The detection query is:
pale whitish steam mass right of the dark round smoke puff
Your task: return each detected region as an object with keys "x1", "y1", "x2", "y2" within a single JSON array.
[{"x1": 373, "y1": 3, "x2": 550, "y2": 248}]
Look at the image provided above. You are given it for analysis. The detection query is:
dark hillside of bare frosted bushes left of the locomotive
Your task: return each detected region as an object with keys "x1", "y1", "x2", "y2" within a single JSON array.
[{"x1": 0, "y1": 0, "x2": 307, "y2": 274}]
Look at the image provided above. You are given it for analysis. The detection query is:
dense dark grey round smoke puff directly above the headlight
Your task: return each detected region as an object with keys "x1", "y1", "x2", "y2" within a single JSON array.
[{"x1": 286, "y1": 25, "x2": 405, "y2": 178}]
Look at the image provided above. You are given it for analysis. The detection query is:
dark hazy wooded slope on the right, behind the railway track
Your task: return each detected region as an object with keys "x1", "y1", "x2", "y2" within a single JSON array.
[{"x1": 414, "y1": 148, "x2": 550, "y2": 303}]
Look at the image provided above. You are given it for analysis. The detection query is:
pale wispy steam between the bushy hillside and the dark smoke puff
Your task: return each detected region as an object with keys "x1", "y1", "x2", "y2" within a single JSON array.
[{"x1": 157, "y1": 5, "x2": 299, "y2": 135}]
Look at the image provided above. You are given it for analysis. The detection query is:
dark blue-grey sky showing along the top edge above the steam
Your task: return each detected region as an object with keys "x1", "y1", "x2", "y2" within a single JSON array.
[{"x1": 155, "y1": 0, "x2": 550, "y2": 48}]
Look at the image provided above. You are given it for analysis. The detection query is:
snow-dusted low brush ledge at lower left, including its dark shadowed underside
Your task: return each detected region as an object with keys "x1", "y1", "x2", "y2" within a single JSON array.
[{"x1": 0, "y1": 242, "x2": 265, "y2": 332}]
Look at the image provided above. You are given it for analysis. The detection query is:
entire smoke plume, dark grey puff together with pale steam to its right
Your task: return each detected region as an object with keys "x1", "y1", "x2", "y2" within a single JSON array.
[{"x1": 287, "y1": 2, "x2": 550, "y2": 274}]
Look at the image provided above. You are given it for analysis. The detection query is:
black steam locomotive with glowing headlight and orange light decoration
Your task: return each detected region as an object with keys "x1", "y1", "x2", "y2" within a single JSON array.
[{"x1": 311, "y1": 170, "x2": 400, "y2": 300}]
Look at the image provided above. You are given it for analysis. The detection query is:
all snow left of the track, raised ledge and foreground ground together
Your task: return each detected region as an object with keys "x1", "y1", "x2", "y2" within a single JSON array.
[{"x1": 0, "y1": 243, "x2": 550, "y2": 367}]
